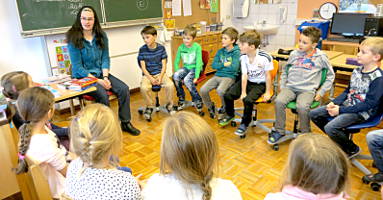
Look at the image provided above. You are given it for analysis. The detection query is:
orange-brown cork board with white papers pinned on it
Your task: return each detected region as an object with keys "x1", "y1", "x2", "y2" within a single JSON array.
[{"x1": 162, "y1": 0, "x2": 222, "y2": 28}]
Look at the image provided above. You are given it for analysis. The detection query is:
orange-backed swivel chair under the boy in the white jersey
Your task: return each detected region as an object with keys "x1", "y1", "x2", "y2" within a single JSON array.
[{"x1": 231, "y1": 60, "x2": 279, "y2": 139}]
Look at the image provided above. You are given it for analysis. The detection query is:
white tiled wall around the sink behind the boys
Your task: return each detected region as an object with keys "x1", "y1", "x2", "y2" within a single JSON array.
[{"x1": 221, "y1": 0, "x2": 297, "y2": 51}]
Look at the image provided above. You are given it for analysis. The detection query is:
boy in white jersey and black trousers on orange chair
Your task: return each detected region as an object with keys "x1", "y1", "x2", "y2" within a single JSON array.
[{"x1": 219, "y1": 30, "x2": 273, "y2": 136}]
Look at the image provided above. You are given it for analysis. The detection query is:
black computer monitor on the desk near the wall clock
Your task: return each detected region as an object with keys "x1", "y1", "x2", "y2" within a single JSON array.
[{"x1": 331, "y1": 13, "x2": 371, "y2": 37}]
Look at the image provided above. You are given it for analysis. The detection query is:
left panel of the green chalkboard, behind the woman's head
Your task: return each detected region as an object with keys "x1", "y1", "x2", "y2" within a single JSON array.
[{"x1": 16, "y1": 0, "x2": 102, "y2": 32}]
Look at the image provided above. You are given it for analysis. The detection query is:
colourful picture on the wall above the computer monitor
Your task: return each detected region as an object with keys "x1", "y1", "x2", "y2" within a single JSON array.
[{"x1": 339, "y1": 0, "x2": 376, "y2": 13}]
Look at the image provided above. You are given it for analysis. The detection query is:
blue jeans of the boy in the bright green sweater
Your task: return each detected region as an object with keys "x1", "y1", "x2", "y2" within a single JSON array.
[{"x1": 173, "y1": 67, "x2": 202, "y2": 102}]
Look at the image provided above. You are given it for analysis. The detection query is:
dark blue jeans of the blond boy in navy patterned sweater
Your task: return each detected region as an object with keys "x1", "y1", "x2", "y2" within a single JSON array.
[{"x1": 309, "y1": 106, "x2": 365, "y2": 154}]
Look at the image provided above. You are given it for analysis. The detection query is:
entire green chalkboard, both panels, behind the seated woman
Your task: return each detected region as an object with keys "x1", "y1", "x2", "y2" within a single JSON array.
[{"x1": 16, "y1": 0, "x2": 162, "y2": 37}]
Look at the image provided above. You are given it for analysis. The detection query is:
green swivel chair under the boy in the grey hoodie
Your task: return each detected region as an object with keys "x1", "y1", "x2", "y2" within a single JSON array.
[{"x1": 267, "y1": 64, "x2": 328, "y2": 151}]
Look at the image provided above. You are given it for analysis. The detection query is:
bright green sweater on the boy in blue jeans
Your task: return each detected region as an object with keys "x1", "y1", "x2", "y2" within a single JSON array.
[{"x1": 174, "y1": 42, "x2": 203, "y2": 78}]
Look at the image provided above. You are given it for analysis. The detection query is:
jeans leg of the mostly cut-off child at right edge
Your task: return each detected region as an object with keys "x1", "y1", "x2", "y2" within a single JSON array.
[{"x1": 366, "y1": 129, "x2": 383, "y2": 173}]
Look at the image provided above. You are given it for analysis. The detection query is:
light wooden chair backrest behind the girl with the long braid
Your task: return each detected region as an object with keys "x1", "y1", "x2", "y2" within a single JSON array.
[{"x1": 26, "y1": 158, "x2": 52, "y2": 199}]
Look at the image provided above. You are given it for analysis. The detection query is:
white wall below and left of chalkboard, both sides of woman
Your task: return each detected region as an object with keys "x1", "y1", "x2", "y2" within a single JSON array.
[{"x1": 0, "y1": 0, "x2": 172, "y2": 89}]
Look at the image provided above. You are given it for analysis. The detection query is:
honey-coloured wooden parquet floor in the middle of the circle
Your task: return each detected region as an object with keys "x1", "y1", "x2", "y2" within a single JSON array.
[{"x1": 55, "y1": 75, "x2": 380, "y2": 200}]
